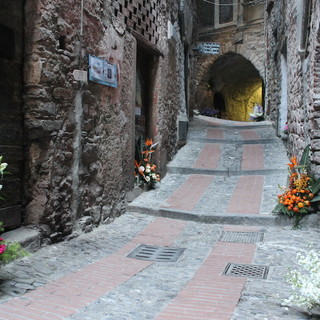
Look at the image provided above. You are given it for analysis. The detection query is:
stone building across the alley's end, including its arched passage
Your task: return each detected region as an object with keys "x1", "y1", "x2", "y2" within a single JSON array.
[{"x1": 193, "y1": 0, "x2": 266, "y2": 121}]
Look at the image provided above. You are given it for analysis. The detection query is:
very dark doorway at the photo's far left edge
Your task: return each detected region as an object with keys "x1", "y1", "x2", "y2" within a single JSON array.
[{"x1": 0, "y1": 0, "x2": 24, "y2": 230}]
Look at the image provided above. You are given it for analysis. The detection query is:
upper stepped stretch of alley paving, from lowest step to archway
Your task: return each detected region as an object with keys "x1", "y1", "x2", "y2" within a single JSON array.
[{"x1": 128, "y1": 117, "x2": 289, "y2": 224}]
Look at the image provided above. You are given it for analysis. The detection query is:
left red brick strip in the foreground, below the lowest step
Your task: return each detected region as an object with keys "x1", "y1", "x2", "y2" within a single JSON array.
[{"x1": 0, "y1": 218, "x2": 186, "y2": 320}]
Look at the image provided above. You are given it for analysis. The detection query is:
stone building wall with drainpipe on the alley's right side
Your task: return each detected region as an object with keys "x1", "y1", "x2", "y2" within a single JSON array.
[{"x1": 266, "y1": 0, "x2": 320, "y2": 176}]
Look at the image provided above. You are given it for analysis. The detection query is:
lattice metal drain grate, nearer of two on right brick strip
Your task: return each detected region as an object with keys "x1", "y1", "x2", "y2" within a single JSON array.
[{"x1": 223, "y1": 263, "x2": 269, "y2": 279}]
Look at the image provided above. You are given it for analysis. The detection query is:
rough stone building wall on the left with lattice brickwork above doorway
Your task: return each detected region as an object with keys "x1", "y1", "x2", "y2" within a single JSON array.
[{"x1": 0, "y1": 0, "x2": 195, "y2": 242}]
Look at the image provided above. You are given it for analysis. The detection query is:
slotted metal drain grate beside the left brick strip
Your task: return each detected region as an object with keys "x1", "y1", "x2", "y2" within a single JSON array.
[{"x1": 127, "y1": 244, "x2": 185, "y2": 262}]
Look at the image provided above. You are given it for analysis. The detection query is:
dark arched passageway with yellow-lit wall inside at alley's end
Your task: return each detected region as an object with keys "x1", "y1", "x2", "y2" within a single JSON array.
[{"x1": 196, "y1": 52, "x2": 264, "y2": 121}]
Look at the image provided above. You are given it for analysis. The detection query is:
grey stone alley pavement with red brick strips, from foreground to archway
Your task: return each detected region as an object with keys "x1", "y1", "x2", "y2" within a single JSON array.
[{"x1": 0, "y1": 117, "x2": 320, "y2": 320}]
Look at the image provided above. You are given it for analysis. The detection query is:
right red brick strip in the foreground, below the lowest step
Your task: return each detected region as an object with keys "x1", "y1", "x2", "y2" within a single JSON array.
[{"x1": 156, "y1": 226, "x2": 260, "y2": 320}]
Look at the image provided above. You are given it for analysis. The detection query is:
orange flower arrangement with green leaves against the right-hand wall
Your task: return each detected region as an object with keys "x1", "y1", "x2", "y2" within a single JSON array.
[{"x1": 273, "y1": 146, "x2": 320, "y2": 227}]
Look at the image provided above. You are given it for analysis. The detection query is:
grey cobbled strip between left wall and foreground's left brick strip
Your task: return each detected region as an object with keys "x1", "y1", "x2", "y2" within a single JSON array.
[{"x1": 0, "y1": 215, "x2": 153, "y2": 300}]
